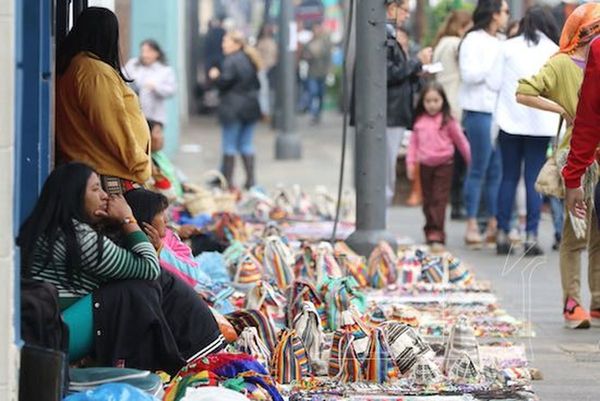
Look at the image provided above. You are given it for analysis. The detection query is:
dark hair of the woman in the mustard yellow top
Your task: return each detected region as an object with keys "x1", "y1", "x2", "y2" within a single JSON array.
[{"x1": 57, "y1": 7, "x2": 131, "y2": 82}]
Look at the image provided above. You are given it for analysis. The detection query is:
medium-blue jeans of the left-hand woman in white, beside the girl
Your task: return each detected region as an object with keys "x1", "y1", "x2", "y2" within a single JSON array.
[{"x1": 463, "y1": 110, "x2": 502, "y2": 219}]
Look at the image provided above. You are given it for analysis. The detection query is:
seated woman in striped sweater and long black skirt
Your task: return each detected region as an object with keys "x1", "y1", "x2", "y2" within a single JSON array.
[{"x1": 17, "y1": 163, "x2": 224, "y2": 373}]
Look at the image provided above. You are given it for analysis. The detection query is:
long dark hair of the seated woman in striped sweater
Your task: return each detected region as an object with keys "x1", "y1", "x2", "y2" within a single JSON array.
[{"x1": 17, "y1": 162, "x2": 103, "y2": 292}]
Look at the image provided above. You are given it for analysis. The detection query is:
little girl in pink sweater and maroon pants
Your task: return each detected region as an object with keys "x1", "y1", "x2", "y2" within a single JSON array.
[{"x1": 406, "y1": 82, "x2": 471, "y2": 247}]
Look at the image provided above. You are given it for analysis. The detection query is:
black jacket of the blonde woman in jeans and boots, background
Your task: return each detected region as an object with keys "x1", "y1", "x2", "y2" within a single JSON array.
[{"x1": 216, "y1": 50, "x2": 261, "y2": 124}]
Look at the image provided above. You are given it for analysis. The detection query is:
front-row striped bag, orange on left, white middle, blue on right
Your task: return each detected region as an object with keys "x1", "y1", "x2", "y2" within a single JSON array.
[{"x1": 363, "y1": 327, "x2": 397, "y2": 384}]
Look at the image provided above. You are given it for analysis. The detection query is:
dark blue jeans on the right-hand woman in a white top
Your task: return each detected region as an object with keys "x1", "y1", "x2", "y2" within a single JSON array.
[{"x1": 497, "y1": 131, "x2": 550, "y2": 235}]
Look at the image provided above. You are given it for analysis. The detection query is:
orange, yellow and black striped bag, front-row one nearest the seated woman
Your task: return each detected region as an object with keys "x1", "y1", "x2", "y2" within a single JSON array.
[{"x1": 271, "y1": 330, "x2": 311, "y2": 384}]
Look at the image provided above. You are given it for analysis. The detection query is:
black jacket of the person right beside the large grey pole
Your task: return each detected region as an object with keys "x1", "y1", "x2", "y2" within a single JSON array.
[{"x1": 386, "y1": 24, "x2": 423, "y2": 128}]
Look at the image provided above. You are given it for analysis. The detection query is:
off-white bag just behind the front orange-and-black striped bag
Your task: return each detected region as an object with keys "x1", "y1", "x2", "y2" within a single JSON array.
[{"x1": 293, "y1": 301, "x2": 325, "y2": 367}]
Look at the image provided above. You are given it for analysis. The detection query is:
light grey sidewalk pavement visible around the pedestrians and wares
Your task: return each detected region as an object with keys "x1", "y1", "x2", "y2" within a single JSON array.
[{"x1": 173, "y1": 114, "x2": 600, "y2": 401}]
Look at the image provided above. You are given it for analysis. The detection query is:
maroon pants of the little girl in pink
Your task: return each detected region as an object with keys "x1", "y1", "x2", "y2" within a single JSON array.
[{"x1": 420, "y1": 164, "x2": 454, "y2": 244}]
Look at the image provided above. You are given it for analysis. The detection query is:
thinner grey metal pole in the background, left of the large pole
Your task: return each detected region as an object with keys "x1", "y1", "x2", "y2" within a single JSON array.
[{"x1": 275, "y1": 0, "x2": 302, "y2": 160}]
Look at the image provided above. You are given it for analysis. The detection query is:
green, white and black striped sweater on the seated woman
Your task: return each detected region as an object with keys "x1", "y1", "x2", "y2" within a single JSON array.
[{"x1": 32, "y1": 222, "x2": 160, "y2": 296}]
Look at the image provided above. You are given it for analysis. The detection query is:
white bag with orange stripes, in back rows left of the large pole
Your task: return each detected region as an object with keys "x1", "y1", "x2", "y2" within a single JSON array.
[{"x1": 263, "y1": 236, "x2": 294, "y2": 290}]
